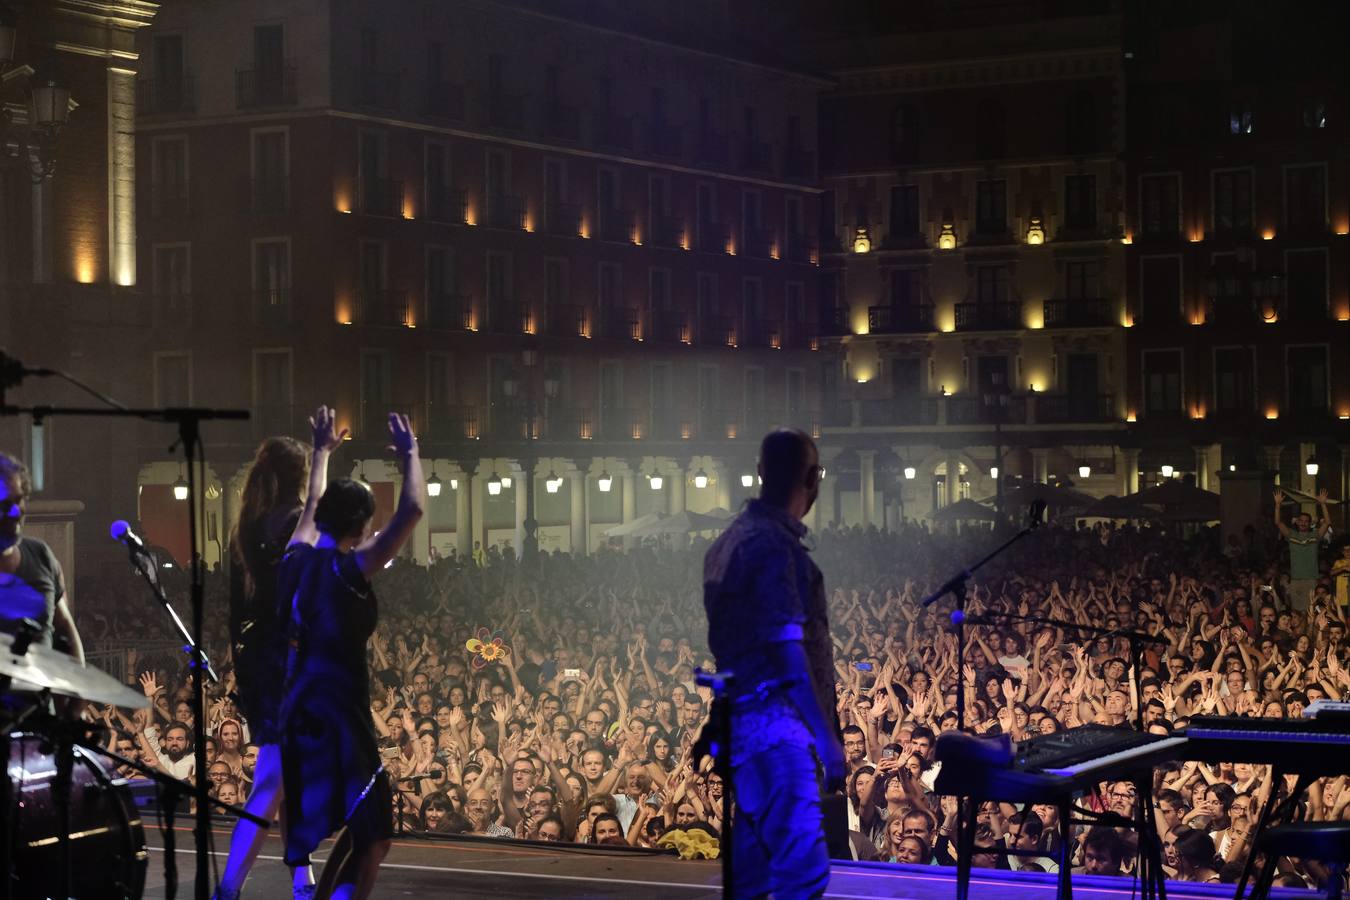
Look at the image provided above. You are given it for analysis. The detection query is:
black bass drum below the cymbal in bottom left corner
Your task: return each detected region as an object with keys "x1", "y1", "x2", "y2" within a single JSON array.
[{"x1": 9, "y1": 733, "x2": 149, "y2": 900}]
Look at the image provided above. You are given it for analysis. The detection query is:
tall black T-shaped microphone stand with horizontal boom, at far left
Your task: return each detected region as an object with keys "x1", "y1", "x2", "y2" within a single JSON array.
[{"x1": 0, "y1": 394, "x2": 248, "y2": 900}]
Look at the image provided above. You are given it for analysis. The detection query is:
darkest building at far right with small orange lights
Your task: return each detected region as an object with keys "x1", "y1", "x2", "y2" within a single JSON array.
[{"x1": 1126, "y1": 4, "x2": 1350, "y2": 518}]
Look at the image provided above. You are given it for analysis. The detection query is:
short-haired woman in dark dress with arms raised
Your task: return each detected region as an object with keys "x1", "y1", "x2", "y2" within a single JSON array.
[{"x1": 278, "y1": 413, "x2": 425, "y2": 900}]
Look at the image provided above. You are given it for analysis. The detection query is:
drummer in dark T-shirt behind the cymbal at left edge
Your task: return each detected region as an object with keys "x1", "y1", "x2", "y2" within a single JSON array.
[{"x1": 0, "y1": 453, "x2": 84, "y2": 664}]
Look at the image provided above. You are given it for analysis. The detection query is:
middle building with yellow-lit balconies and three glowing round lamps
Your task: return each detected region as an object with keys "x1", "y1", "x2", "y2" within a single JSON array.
[{"x1": 818, "y1": 4, "x2": 1135, "y2": 526}]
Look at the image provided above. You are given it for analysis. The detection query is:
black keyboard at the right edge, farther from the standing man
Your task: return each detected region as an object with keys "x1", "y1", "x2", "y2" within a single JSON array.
[{"x1": 1183, "y1": 715, "x2": 1350, "y2": 775}]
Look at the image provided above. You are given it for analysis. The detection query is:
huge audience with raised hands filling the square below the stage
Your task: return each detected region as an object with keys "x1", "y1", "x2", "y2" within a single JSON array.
[{"x1": 76, "y1": 493, "x2": 1350, "y2": 885}]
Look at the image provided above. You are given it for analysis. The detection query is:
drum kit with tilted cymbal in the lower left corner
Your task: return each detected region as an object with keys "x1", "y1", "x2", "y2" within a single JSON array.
[{"x1": 0, "y1": 633, "x2": 164, "y2": 900}]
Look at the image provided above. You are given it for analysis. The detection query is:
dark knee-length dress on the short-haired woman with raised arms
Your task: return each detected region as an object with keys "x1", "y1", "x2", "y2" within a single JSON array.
[{"x1": 278, "y1": 544, "x2": 393, "y2": 865}]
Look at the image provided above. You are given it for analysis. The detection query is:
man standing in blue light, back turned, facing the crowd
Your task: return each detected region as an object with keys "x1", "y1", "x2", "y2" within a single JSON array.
[{"x1": 703, "y1": 429, "x2": 844, "y2": 900}]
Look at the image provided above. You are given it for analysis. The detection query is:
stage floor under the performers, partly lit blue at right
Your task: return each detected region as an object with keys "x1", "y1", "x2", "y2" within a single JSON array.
[{"x1": 144, "y1": 828, "x2": 1315, "y2": 900}]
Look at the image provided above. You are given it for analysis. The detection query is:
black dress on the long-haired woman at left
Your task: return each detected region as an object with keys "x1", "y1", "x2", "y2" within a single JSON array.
[{"x1": 230, "y1": 509, "x2": 300, "y2": 745}]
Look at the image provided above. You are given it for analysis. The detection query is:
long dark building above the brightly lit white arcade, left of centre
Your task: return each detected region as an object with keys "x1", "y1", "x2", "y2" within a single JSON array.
[{"x1": 136, "y1": 0, "x2": 826, "y2": 559}]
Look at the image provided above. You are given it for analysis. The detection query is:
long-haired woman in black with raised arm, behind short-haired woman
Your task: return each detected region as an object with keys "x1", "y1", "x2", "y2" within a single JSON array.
[{"x1": 216, "y1": 406, "x2": 342, "y2": 900}]
